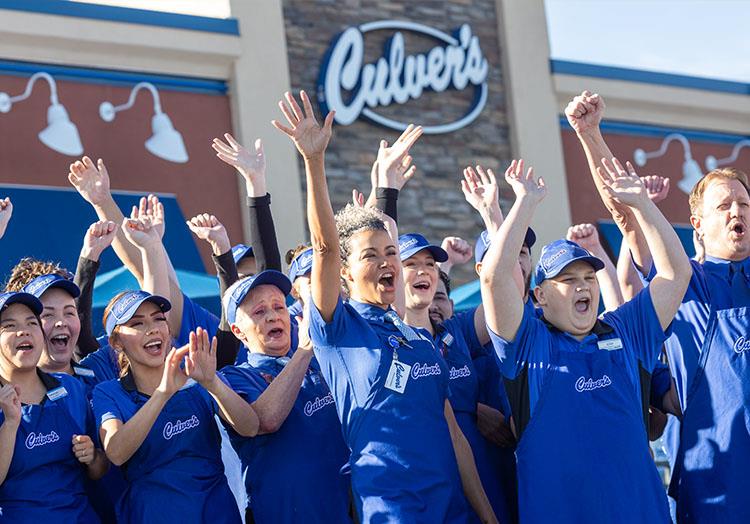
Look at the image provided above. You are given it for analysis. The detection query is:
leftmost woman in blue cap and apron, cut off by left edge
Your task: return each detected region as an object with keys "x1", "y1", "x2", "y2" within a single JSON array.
[{"x1": 0, "y1": 293, "x2": 109, "y2": 523}]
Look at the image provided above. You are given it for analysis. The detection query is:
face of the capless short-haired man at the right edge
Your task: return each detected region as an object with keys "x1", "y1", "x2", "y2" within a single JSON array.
[{"x1": 690, "y1": 178, "x2": 750, "y2": 261}]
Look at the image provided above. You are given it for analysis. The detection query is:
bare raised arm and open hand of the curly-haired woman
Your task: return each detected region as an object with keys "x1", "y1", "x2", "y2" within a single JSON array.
[{"x1": 272, "y1": 91, "x2": 341, "y2": 322}]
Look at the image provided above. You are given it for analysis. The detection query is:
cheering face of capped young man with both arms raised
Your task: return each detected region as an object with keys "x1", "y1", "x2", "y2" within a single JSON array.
[{"x1": 534, "y1": 260, "x2": 599, "y2": 339}]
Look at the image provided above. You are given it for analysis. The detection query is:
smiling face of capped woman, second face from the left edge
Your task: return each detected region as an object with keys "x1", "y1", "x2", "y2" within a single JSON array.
[{"x1": 40, "y1": 287, "x2": 81, "y2": 369}]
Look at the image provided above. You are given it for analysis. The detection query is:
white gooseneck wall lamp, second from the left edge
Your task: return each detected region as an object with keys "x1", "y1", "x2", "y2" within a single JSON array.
[{"x1": 99, "y1": 82, "x2": 188, "y2": 164}]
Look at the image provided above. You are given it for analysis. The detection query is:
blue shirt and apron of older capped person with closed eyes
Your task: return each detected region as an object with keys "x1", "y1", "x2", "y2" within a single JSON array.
[{"x1": 221, "y1": 352, "x2": 351, "y2": 524}]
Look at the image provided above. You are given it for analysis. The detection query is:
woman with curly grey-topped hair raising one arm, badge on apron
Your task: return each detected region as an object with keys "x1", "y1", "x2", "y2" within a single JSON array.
[{"x1": 273, "y1": 92, "x2": 496, "y2": 523}]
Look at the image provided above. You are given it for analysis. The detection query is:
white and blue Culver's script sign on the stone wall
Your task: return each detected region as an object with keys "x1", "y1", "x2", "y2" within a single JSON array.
[{"x1": 318, "y1": 20, "x2": 488, "y2": 134}]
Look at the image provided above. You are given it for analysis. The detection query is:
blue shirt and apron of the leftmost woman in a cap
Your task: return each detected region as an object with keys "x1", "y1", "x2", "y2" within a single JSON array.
[{"x1": 0, "y1": 371, "x2": 99, "y2": 524}]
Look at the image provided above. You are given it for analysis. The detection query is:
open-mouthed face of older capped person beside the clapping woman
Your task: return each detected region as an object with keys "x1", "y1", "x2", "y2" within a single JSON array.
[{"x1": 232, "y1": 284, "x2": 291, "y2": 357}]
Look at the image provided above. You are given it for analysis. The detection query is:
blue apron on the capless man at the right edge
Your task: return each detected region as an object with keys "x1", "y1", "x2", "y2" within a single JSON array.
[{"x1": 670, "y1": 307, "x2": 750, "y2": 524}]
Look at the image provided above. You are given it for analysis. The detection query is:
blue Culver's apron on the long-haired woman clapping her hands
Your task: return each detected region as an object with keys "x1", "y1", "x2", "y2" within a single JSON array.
[{"x1": 118, "y1": 384, "x2": 241, "y2": 524}]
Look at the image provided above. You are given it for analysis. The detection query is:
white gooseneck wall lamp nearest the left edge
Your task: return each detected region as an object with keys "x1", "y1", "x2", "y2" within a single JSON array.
[{"x1": 0, "y1": 72, "x2": 83, "y2": 156}]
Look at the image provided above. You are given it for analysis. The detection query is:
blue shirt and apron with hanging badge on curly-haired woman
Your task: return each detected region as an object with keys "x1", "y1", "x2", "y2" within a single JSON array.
[{"x1": 310, "y1": 299, "x2": 469, "y2": 523}]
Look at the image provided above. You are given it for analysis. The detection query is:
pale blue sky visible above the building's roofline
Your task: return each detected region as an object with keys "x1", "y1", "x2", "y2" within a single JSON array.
[{"x1": 72, "y1": 0, "x2": 750, "y2": 82}]
